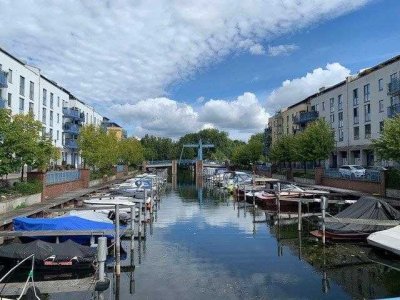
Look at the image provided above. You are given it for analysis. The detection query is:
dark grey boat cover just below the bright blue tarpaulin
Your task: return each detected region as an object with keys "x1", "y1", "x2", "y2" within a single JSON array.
[{"x1": 0, "y1": 240, "x2": 97, "y2": 262}]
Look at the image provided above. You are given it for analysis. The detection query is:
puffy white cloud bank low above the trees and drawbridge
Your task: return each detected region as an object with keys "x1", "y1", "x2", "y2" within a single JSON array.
[{"x1": 110, "y1": 93, "x2": 269, "y2": 139}]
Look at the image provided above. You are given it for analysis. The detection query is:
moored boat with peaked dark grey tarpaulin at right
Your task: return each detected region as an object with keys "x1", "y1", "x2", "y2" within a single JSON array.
[{"x1": 311, "y1": 196, "x2": 400, "y2": 240}]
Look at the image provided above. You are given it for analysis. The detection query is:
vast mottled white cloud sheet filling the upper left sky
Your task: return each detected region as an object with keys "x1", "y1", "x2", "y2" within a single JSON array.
[{"x1": 0, "y1": 0, "x2": 368, "y2": 105}]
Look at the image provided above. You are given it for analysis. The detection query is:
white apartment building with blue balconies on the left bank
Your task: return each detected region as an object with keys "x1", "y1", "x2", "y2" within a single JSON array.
[{"x1": 0, "y1": 48, "x2": 107, "y2": 167}]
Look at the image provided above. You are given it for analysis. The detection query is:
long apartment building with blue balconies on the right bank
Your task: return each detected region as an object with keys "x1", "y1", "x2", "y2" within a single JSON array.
[{"x1": 269, "y1": 55, "x2": 400, "y2": 167}]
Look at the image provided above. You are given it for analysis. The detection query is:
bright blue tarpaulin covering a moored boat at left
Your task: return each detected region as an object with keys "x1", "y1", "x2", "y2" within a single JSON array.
[{"x1": 13, "y1": 216, "x2": 125, "y2": 244}]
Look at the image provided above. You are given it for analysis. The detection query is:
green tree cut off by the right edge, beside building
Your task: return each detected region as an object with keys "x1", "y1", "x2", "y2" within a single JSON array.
[{"x1": 373, "y1": 115, "x2": 400, "y2": 162}]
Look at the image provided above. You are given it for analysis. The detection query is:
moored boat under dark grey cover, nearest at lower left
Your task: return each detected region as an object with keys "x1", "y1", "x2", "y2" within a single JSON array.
[{"x1": 0, "y1": 240, "x2": 97, "y2": 270}]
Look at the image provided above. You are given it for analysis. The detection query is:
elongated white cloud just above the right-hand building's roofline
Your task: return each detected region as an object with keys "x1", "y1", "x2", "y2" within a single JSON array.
[{"x1": 267, "y1": 63, "x2": 350, "y2": 112}]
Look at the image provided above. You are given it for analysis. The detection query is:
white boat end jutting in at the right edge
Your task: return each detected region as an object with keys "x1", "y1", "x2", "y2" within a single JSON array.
[{"x1": 367, "y1": 226, "x2": 400, "y2": 255}]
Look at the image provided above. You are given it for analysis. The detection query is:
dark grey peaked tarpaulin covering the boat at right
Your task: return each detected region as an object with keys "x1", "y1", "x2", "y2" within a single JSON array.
[{"x1": 326, "y1": 196, "x2": 400, "y2": 234}]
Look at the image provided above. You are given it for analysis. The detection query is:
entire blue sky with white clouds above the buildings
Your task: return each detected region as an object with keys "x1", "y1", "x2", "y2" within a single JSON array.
[{"x1": 0, "y1": 0, "x2": 400, "y2": 139}]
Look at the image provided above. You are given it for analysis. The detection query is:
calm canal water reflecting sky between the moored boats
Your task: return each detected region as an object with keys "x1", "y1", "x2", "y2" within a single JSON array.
[{"x1": 41, "y1": 175, "x2": 400, "y2": 300}]
